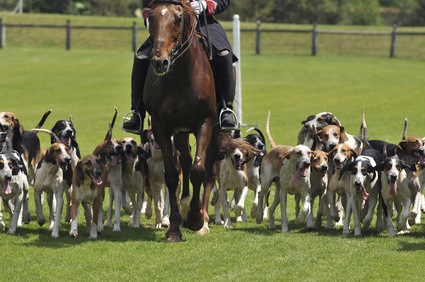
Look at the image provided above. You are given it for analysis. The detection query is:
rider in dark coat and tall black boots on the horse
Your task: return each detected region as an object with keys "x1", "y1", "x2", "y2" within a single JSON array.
[{"x1": 123, "y1": 0, "x2": 239, "y2": 134}]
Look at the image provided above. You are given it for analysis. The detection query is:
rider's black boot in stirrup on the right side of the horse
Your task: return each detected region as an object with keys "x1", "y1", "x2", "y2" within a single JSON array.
[{"x1": 217, "y1": 52, "x2": 239, "y2": 130}]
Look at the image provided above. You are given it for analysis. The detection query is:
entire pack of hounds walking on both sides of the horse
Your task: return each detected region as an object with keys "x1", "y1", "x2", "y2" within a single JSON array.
[{"x1": 0, "y1": 109, "x2": 425, "y2": 238}]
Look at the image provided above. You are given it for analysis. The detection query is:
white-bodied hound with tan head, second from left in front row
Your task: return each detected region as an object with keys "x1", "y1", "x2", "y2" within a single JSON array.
[{"x1": 34, "y1": 140, "x2": 72, "y2": 238}]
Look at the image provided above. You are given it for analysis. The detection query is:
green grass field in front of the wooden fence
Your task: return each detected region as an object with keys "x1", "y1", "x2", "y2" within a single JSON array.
[{"x1": 0, "y1": 12, "x2": 425, "y2": 281}]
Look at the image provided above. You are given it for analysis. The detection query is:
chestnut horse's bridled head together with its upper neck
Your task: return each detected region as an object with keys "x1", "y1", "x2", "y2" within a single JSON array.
[{"x1": 149, "y1": 0, "x2": 194, "y2": 75}]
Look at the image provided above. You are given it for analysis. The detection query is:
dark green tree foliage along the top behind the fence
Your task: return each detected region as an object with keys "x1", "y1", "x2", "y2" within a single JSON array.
[{"x1": 0, "y1": 0, "x2": 425, "y2": 25}]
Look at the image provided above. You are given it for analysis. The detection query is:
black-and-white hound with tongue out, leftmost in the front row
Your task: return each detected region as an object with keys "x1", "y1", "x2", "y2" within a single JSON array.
[{"x1": 0, "y1": 150, "x2": 30, "y2": 234}]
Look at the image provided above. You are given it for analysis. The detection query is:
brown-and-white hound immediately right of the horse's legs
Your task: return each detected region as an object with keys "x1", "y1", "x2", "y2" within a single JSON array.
[{"x1": 214, "y1": 135, "x2": 256, "y2": 228}]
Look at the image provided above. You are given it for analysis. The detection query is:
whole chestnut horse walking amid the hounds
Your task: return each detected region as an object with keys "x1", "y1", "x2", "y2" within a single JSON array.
[{"x1": 144, "y1": 0, "x2": 219, "y2": 242}]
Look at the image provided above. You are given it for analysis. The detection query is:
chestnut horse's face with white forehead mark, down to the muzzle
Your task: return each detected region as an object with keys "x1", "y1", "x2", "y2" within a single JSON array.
[{"x1": 149, "y1": 4, "x2": 184, "y2": 76}]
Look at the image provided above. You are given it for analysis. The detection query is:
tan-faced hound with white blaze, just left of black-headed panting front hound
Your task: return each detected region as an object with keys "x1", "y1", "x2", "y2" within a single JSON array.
[{"x1": 326, "y1": 143, "x2": 357, "y2": 229}]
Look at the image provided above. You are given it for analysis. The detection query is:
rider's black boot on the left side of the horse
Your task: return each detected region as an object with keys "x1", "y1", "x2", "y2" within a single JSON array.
[{"x1": 123, "y1": 55, "x2": 150, "y2": 134}]
